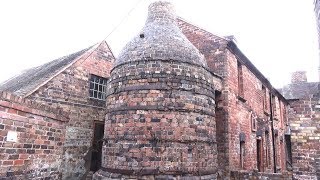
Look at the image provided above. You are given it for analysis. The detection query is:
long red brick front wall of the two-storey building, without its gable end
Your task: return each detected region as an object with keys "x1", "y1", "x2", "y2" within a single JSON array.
[{"x1": 220, "y1": 48, "x2": 286, "y2": 176}]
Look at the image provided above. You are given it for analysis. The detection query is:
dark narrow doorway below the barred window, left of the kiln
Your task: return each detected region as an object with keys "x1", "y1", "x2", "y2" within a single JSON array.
[{"x1": 90, "y1": 121, "x2": 104, "y2": 172}]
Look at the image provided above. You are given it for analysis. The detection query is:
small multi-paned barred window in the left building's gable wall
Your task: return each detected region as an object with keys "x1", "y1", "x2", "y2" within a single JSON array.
[{"x1": 89, "y1": 75, "x2": 107, "y2": 101}]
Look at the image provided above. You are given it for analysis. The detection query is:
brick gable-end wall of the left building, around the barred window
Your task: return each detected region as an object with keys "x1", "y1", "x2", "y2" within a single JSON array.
[{"x1": 28, "y1": 42, "x2": 114, "y2": 179}]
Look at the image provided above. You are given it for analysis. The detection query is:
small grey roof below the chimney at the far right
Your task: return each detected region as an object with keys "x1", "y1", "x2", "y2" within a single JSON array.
[{"x1": 279, "y1": 82, "x2": 320, "y2": 99}]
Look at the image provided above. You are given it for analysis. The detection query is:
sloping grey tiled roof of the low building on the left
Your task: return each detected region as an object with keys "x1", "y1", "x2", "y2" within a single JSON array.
[{"x1": 0, "y1": 46, "x2": 92, "y2": 96}]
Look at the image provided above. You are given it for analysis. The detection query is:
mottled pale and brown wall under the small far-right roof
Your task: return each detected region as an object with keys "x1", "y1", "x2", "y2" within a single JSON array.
[{"x1": 290, "y1": 93, "x2": 320, "y2": 179}]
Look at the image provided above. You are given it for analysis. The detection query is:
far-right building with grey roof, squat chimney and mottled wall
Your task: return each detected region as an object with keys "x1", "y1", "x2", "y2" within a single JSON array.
[{"x1": 280, "y1": 71, "x2": 320, "y2": 179}]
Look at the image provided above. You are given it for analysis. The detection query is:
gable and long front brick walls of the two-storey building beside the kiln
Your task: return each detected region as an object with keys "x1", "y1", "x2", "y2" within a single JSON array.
[{"x1": 178, "y1": 19, "x2": 287, "y2": 179}]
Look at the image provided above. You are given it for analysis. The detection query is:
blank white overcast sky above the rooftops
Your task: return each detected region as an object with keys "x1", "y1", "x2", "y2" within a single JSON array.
[{"x1": 0, "y1": 0, "x2": 319, "y2": 87}]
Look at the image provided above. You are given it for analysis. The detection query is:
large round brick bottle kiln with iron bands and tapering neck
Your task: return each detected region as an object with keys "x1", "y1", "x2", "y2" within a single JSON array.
[{"x1": 94, "y1": 2, "x2": 220, "y2": 179}]
